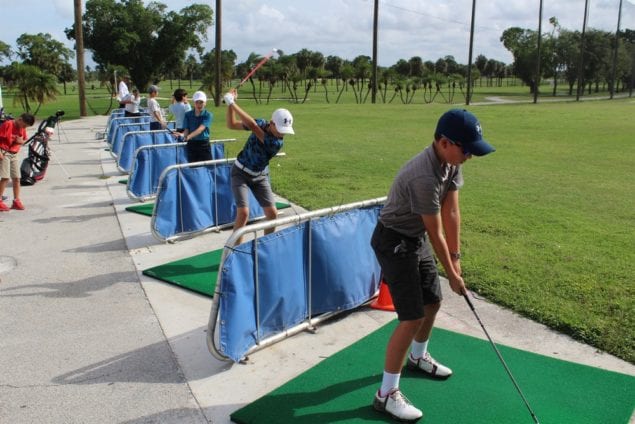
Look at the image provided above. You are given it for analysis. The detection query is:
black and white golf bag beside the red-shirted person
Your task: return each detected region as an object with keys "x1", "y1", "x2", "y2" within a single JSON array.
[{"x1": 20, "y1": 110, "x2": 64, "y2": 186}]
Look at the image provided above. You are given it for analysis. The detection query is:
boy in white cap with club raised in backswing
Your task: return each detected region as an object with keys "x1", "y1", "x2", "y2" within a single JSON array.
[{"x1": 223, "y1": 90, "x2": 295, "y2": 245}]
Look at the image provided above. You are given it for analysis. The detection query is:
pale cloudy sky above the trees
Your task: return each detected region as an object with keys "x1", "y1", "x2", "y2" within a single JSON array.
[{"x1": 0, "y1": 0, "x2": 635, "y2": 66}]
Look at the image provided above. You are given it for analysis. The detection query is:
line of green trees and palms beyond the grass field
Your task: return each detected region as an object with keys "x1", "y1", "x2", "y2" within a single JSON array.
[{"x1": 0, "y1": 0, "x2": 635, "y2": 111}]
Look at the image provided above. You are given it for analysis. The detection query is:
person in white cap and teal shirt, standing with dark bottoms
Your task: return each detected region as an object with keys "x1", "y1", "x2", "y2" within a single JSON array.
[{"x1": 183, "y1": 91, "x2": 214, "y2": 162}]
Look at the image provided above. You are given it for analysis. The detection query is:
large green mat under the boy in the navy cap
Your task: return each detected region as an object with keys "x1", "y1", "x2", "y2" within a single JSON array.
[{"x1": 231, "y1": 321, "x2": 635, "y2": 424}]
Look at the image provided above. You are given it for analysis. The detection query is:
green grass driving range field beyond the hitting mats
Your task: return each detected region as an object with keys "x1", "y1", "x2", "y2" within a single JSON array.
[{"x1": 5, "y1": 84, "x2": 635, "y2": 363}]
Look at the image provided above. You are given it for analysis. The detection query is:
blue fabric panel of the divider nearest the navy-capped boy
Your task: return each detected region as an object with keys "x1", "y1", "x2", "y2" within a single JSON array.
[{"x1": 214, "y1": 205, "x2": 381, "y2": 361}]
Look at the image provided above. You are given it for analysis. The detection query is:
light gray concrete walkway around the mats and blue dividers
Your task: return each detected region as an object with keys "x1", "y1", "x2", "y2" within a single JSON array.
[{"x1": 0, "y1": 117, "x2": 635, "y2": 424}]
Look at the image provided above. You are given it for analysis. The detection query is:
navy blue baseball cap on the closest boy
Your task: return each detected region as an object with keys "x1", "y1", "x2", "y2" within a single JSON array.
[{"x1": 435, "y1": 109, "x2": 496, "y2": 156}]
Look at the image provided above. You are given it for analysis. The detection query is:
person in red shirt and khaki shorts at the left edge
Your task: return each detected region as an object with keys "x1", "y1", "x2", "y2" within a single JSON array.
[{"x1": 0, "y1": 113, "x2": 35, "y2": 212}]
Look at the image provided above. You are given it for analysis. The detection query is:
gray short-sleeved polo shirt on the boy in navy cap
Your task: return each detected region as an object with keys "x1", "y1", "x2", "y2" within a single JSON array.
[{"x1": 379, "y1": 145, "x2": 463, "y2": 237}]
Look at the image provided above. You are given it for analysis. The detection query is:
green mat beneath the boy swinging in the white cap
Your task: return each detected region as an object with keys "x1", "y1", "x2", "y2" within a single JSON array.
[{"x1": 143, "y1": 249, "x2": 223, "y2": 297}]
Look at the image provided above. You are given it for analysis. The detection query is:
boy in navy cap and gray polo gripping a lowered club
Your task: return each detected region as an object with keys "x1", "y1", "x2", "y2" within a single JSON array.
[{"x1": 371, "y1": 109, "x2": 494, "y2": 422}]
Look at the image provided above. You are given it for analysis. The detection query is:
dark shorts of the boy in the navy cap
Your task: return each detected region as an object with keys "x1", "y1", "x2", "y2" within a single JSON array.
[{"x1": 371, "y1": 222, "x2": 443, "y2": 321}]
